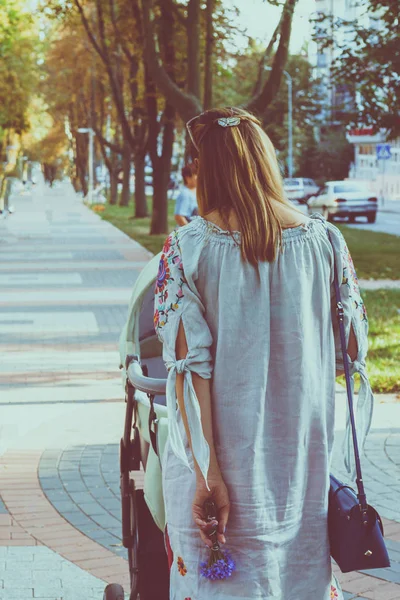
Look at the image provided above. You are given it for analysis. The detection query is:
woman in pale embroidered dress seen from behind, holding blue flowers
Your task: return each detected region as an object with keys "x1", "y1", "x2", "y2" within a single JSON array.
[{"x1": 155, "y1": 109, "x2": 372, "y2": 600}]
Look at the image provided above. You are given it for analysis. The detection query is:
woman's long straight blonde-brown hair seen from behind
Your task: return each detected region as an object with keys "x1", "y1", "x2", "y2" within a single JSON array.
[{"x1": 189, "y1": 108, "x2": 291, "y2": 265}]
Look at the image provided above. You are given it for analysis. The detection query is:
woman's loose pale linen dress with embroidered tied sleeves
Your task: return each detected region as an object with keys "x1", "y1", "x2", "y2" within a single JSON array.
[{"x1": 155, "y1": 217, "x2": 373, "y2": 600}]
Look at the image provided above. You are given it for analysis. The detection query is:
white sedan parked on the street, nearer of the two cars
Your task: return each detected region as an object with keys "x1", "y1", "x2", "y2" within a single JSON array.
[{"x1": 307, "y1": 181, "x2": 378, "y2": 223}]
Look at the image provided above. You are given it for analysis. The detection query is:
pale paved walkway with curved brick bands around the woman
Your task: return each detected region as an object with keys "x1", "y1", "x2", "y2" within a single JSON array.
[{"x1": 0, "y1": 180, "x2": 400, "y2": 600}]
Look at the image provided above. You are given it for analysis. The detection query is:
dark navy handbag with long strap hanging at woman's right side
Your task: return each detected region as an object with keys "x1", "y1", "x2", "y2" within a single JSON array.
[{"x1": 327, "y1": 230, "x2": 390, "y2": 573}]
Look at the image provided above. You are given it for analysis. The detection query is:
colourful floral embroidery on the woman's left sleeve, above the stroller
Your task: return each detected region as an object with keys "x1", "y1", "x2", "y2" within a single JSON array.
[{"x1": 154, "y1": 231, "x2": 186, "y2": 333}]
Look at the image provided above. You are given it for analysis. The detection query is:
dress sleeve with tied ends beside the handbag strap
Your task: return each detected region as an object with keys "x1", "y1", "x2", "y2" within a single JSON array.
[{"x1": 329, "y1": 226, "x2": 374, "y2": 477}]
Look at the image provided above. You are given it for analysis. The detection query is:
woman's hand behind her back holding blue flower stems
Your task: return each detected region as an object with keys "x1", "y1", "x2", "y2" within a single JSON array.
[{"x1": 192, "y1": 475, "x2": 230, "y2": 548}]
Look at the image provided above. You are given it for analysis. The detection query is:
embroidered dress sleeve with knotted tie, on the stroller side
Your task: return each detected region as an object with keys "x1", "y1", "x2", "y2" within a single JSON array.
[{"x1": 154, "y1": 231, "x2": 216, "y2": 482}]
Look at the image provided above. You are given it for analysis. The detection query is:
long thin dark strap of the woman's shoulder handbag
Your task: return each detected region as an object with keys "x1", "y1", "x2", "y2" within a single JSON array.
[{"x1": 326, "y1": 226, "x2": 368, "y2": 512}]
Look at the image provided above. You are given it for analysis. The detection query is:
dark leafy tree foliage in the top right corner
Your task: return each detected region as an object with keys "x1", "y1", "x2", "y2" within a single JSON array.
[{"x1": 315, "y1": 0, "x2": 400, "y2": 137}]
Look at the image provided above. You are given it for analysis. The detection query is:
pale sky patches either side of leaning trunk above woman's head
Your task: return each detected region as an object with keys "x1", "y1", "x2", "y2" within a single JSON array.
[{"x1": 225, "y1": 0, "x2": 315, "y2": 52}]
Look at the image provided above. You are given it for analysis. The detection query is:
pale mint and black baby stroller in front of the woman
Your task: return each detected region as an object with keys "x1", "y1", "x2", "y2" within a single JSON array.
[{"x1": 103, "y1": 255, "x2": 169, "y2": 600}]
